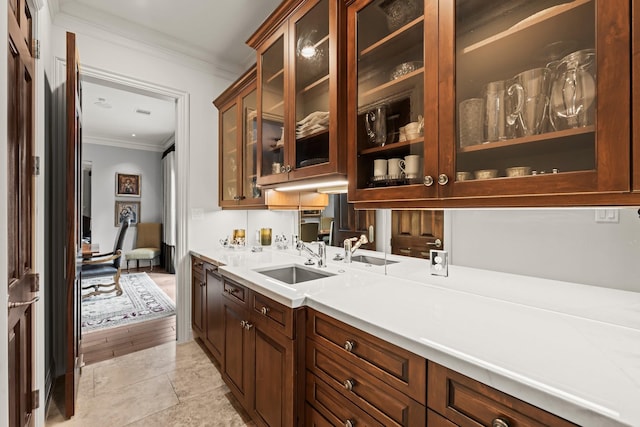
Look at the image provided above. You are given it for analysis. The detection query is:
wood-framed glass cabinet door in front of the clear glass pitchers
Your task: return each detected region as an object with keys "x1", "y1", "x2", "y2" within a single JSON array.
[{"x1": 439, "y1": 0, "x2": 630, "y2": 197}]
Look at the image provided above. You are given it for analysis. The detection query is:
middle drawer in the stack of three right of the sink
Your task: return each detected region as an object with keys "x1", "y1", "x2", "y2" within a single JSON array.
[{"x1": 306, "y1": 340, "x2": 426, "y2": 426}]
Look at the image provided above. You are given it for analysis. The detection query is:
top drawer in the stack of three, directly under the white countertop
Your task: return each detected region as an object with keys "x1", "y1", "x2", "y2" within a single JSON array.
[{"x1": 307, "y1": 309, "x2": 427, "y2": 405}]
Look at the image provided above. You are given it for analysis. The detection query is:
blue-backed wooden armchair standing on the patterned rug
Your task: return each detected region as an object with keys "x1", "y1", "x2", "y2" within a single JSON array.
[{"x1": 80, "y1": 219, "x2": 129, "y2": 299}]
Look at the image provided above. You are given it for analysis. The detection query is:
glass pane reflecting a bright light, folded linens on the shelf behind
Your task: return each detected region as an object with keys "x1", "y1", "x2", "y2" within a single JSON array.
[{"x1": 294, "y1": 0, "x2": 332, "y2": 169}]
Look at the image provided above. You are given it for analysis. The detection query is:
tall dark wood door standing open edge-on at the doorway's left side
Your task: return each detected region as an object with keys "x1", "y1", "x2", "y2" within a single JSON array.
[{"x1": 64, "y1": 33, "x2": 82, "y2": 418}]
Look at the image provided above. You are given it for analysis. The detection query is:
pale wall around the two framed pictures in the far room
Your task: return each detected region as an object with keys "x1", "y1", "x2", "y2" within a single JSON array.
[{"x1": 82, "y1": 143, "x2": 163, "y2": 252}]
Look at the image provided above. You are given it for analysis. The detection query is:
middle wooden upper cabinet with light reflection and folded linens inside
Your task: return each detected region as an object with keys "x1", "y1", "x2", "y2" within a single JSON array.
[{"x1": 247, "y1": 0, "x2": 346, "y2": 186}]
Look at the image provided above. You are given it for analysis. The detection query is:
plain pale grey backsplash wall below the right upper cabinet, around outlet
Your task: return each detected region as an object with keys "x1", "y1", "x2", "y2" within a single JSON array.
[{"x1": 449, "y1": 208, "x2": 640, "y2": 292}]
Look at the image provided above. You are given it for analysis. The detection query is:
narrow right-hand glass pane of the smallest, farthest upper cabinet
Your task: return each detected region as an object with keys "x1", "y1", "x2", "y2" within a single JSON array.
[{"x1": 242, "y1": 90, "x2": 262, "y2": 199}]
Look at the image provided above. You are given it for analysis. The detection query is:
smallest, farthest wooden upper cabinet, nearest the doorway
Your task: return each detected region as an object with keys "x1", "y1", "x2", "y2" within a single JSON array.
[{"x1": 214, "y1": 67, "x2": 265, "y2": 209}]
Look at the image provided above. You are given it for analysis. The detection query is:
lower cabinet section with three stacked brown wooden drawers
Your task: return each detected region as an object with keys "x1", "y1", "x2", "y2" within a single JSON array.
[{"x1": 306, "y1": 309, "x2": 427, "y2": 426}]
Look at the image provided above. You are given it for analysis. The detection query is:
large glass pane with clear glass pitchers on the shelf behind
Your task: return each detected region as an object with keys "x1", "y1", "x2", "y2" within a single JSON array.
[{"x1": 455, "y1": 0, "x2": 600, "y2": 184}]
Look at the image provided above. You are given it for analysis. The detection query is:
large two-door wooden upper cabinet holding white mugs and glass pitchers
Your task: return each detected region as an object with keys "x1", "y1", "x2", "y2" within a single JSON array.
[{"x1": 347, "y1": 0, "x2": 640, "y2": 207}]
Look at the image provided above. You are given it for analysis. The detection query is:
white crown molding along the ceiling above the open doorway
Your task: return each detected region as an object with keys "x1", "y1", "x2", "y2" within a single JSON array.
[{"x1": 52, "y1": 10, "x2": 244, "y2": 80}]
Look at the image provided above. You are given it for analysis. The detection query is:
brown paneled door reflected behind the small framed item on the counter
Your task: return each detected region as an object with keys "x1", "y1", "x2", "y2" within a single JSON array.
[{"x1": 391, "y1": 210, "x2": 444, "y2": 259}]
